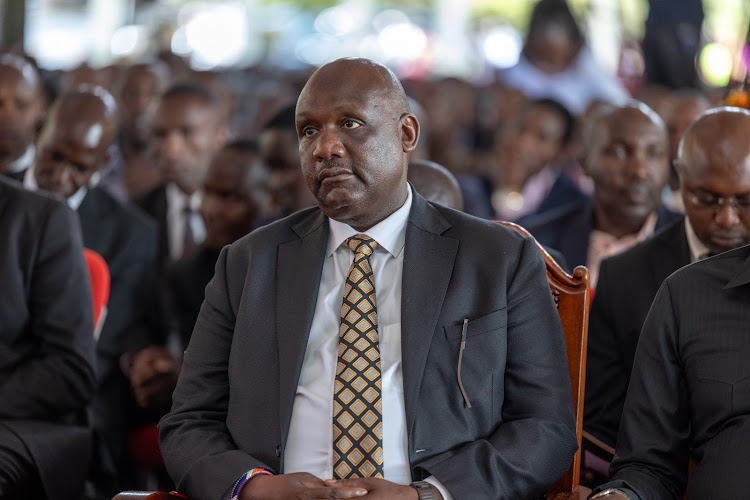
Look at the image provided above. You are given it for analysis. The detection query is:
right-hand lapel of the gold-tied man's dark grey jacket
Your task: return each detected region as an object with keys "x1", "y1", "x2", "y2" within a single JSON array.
[{"x1": 401, "y1": 191, "x2": 458, "y2": 435}]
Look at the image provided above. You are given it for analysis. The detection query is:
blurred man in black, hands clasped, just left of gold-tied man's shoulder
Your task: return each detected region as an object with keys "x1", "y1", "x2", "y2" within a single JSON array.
[{"x1": 130, "y1": 140, "x2": 271, "y2": 416}]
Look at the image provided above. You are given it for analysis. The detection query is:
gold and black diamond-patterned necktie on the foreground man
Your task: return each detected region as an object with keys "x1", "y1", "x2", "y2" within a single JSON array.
[{"x1": 333, "y1": 234, "x2": 383, "y2": 479}]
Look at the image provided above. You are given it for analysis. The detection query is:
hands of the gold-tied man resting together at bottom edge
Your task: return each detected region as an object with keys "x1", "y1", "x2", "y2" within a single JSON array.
[{"x1": 240, "y1": 472, "x2": 418, "y2": 500}]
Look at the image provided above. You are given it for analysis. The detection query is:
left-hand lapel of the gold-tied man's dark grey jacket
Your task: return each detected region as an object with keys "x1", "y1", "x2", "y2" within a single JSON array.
[{"x1": 276, "y1": 210, "x2": 328, "y2": 449}]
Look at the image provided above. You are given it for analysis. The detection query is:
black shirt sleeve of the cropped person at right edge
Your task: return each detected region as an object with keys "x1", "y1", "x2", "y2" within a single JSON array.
[{"x1": 602, "y1": 282, "x2": 690, "y2": 499}]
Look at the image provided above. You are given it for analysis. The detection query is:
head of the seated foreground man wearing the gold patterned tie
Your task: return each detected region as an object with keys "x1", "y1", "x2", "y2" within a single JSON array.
[{"x1": 296, "y1": 59, "x2": 419, "y2": 231}]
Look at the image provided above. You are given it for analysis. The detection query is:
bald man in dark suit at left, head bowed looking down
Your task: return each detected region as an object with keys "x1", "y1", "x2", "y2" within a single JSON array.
[{"x1": 33, "y1": 86, "x2": 167, "y2": 494}]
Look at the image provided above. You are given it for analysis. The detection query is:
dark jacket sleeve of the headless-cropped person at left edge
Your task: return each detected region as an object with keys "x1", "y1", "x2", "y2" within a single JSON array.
[{"x1": 0, "y1": 199, "x2": 95, "y2": 419}]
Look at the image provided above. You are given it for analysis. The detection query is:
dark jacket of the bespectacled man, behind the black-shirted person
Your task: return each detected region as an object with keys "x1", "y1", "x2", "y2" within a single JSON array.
[{"x1": 583, "y1": 218, "x2": 690, "y2": 447}]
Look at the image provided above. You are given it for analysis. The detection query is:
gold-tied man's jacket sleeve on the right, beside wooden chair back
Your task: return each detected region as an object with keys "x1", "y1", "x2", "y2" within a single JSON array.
[{"x1": 419, "y1": 238, "x2": 578, "y2": 498}]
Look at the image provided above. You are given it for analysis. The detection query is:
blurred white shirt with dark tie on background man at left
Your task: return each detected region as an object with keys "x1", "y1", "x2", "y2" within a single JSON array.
[{"x1": 166, "y1": 182, "x2": 206, "y2": 260}]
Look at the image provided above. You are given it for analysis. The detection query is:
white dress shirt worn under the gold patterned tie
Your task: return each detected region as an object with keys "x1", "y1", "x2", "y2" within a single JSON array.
[{"x1": 283, "y1": 189, "x2": 452, "y2": 499}]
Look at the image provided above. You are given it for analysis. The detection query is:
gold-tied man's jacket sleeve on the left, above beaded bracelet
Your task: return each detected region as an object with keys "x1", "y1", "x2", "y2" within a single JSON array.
[{"x1": 159, "y1": 248, "x2": 264, "y2": 498}]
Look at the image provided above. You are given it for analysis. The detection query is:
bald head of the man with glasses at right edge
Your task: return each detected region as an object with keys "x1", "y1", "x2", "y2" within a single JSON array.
[{"x1": 675, "y1": 107, "x2": 750, "y2": 253}]
